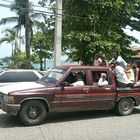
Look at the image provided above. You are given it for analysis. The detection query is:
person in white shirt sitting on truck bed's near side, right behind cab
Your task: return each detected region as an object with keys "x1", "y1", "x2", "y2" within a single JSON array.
[{"x1": 115, "y1": 61, "x2": 134, "y2": 87}]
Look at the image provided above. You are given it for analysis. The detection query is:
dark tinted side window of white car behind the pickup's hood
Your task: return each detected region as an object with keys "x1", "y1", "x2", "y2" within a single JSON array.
[{"x1": 0, "y1": 71, "x2": 38, "y2": 82}]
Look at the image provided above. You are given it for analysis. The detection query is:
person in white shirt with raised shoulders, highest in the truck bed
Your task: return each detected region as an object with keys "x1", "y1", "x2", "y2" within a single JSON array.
[{"x1": 108, "y1": 53, "x2": 127, "y2": 69}]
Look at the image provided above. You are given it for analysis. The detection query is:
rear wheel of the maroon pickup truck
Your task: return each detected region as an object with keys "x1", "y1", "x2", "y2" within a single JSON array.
[{"x1": 116, "y1": 98, "x2": 134, "y2": 116}]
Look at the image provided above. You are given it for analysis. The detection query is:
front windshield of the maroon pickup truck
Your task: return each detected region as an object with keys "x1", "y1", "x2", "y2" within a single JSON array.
[{"x1": 38, "y1": 69, "x2": 66, "y2": 85}]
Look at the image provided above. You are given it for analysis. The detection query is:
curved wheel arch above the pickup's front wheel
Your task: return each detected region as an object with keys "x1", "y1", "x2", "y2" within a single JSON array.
[{"x1": 20, "y1": 97, "x2": 50, "y2": 112}]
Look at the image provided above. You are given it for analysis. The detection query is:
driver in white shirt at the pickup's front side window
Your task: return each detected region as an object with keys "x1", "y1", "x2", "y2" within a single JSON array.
[{"x1": 70, "y1": 73, "x2": 85, "y2": 86}]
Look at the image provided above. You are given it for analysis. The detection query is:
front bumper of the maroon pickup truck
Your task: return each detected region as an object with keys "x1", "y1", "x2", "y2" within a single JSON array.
[{"x1": 0, "y1": 103, "x2": 20, "y2": 116}]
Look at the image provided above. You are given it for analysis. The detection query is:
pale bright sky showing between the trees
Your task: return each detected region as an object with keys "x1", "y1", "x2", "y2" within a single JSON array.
[{"x1": 0, "y1": 0, "x2": 140, "y2": 58}]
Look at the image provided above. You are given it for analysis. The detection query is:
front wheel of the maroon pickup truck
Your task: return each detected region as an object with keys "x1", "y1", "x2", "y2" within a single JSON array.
[{"x1": 19, "y1": 100, "x2": 47, "y2": 125}]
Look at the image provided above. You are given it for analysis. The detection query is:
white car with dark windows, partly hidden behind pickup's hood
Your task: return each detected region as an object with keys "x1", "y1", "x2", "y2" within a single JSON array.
[{"x1": 0, "y1": 69, "x2": 42, "y2": 87}]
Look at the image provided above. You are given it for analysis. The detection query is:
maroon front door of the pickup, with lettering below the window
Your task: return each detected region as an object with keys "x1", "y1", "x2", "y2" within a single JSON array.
[{"x1": 55, "y1": 70, "x2": 91, "y2": 111}]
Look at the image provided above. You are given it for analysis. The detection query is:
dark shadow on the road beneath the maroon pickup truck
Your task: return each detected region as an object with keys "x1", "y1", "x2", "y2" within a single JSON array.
[{"x1": 0, "y1": 108, "x2": 140, "y2": 128}]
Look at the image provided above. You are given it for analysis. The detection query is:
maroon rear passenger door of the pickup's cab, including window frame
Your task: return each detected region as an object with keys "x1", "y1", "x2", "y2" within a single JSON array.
[{"x1": 91, "y1": 70, "x2": 116, "y2": 110}]
